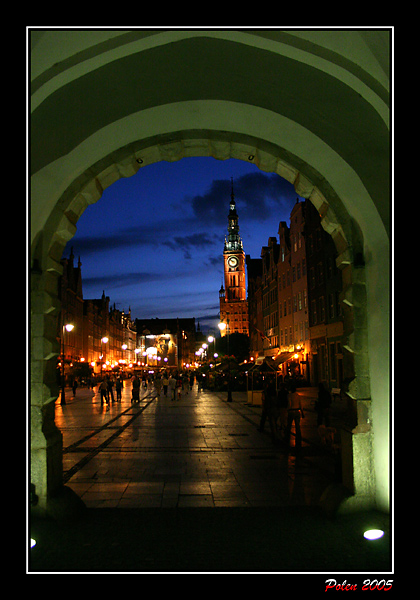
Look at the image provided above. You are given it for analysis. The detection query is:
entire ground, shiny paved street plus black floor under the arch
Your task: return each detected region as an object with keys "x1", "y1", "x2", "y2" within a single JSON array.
[{"x1": 29, "y1": 386, "x2": 391, "y2": 573}]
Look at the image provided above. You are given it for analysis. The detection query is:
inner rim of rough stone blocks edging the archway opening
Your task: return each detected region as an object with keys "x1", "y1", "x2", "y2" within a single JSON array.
[{"x1": 32, "y1": 134, "x2": 374, "y2": 510}]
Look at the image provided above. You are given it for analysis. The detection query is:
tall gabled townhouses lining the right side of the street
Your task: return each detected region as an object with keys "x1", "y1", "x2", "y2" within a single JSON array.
[{"x1": 247, "y1": 200, "x2": 343, "y2": 388}]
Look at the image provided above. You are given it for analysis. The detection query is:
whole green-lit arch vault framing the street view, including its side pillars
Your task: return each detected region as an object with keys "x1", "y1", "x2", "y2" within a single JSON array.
[{"x1": 28, "y1": 30, "x2": 391, "y2": 510}]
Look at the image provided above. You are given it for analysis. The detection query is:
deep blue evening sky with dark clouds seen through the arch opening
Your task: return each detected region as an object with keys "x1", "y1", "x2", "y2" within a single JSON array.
[{"x1": 63, "y1": 158, "x2": 298, "y2": 329}]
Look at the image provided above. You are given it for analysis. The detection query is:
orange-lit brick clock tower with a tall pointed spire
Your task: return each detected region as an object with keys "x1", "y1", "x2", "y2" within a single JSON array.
[{"x1": 219, "y1": 182, "x2": 249, "y2": 336}]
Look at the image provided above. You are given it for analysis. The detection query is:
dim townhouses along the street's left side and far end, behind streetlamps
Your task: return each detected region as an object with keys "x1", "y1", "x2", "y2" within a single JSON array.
[{"x1": 57, "y1": 249, "x2": 196, "y2": 382}]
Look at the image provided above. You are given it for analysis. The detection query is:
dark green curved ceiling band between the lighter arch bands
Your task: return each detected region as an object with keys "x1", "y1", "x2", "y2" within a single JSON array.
[{"x1": 31, "y1": 32, "x2": 389, "y2": 236}]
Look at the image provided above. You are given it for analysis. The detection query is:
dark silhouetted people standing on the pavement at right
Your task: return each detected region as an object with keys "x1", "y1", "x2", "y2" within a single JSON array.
[{"x1": 258, "y1": 378, "x2": 331, "y2": 448}]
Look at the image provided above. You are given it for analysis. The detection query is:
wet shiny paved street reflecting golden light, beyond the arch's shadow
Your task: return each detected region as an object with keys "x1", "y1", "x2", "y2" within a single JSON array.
[{"x1": 56, "y1": 386, "x2": 337, "y2": 508}]
